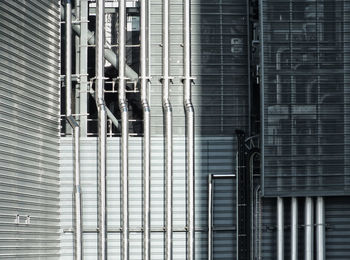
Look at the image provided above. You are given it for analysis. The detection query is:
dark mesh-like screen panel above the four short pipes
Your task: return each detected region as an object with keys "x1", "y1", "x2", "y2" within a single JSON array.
[{"x1": 261, "y1": 0, "x2": 350, "y2": 196}]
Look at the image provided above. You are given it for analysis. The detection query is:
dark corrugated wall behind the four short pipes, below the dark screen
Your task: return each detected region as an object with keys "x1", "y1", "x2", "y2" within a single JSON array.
[{"x1": 262, "y1": 197, "x2": 350, "y2": 260}]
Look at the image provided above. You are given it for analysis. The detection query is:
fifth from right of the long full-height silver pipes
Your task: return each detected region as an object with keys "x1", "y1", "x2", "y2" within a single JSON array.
[{"x1": 96, "y1": 0, "x2": 107, "y2": 260}]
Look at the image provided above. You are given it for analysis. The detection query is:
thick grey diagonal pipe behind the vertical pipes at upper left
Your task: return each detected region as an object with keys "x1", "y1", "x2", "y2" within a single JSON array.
[{"x1": 61, "y1": 7, "x2": 139, "y2": 82}]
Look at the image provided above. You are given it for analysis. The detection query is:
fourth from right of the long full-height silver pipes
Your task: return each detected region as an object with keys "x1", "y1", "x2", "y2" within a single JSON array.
[{"x1": 118, "y1": 0, "x2": 129, "y2": 260}]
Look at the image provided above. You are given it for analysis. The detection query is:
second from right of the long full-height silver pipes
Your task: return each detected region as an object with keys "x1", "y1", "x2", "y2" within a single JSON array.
[{"x1": 162, "y1": 0, "x2": 173, "y2": 260}]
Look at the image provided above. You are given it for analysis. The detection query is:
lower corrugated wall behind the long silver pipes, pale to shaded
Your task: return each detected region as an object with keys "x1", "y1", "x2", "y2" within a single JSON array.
[{"x1": 61, "y1": 137, "x2": 236, "y2": 260}]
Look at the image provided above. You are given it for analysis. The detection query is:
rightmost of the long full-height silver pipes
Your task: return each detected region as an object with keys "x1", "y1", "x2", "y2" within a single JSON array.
[{"x1": 183, "y1": 0, "x2": 195, "y2": 260}]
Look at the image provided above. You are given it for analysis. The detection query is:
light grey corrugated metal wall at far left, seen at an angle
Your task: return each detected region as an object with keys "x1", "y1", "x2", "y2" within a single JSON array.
[{"x1": 0, "y1": 0, "x2": 60, "y2": 259}]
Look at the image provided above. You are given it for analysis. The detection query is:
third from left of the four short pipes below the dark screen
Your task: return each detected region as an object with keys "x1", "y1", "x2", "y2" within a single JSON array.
[{"x1": 305, "y1": 197, "x2": 314, "y2": 260}]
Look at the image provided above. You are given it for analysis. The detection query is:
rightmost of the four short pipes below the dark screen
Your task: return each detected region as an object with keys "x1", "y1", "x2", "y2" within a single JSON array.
[{"x1": 316, "y1": 197, "x2": 326, "y2": 260}]
